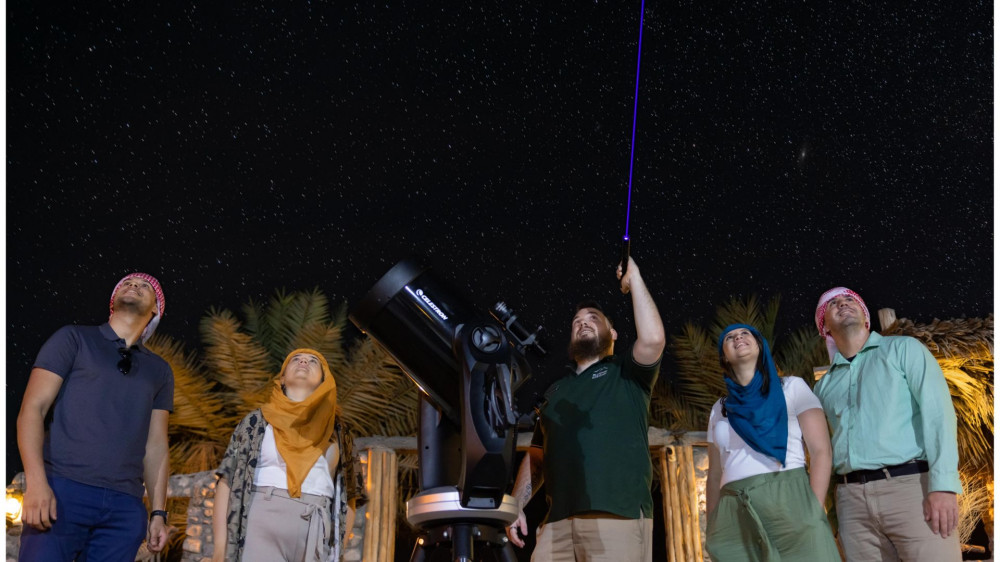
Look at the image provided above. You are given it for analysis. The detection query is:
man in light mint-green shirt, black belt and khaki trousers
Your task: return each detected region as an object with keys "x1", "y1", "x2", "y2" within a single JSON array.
[{"x1": 814, "y1": 287, "x2": 962, "y2": 562}]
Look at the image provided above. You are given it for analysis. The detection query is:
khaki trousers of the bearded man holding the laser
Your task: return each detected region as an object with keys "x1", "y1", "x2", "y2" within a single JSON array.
[{"x1": 531, "y1": 513, "x2": 653, "y2": 562}]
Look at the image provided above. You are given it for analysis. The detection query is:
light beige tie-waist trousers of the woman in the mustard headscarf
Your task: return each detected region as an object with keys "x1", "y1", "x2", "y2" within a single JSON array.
[{"x1": 243, "y1": 486, "x2": 331, "y2": 562}]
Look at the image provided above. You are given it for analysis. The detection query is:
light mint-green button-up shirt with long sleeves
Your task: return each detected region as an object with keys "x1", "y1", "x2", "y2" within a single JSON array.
[{"x1": 813, "y1": 332, "x2": 962, "y2": 494}]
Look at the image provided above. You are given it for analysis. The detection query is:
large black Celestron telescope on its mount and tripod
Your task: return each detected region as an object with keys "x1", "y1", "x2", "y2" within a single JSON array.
[{"x1": 350, "y1": 259, "x2": 546, "y2": 562}]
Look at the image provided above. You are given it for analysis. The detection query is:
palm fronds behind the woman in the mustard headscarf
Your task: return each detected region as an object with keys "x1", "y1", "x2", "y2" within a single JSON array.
[{"x1": 148, "y1": 289, "x2": 417, "y2": 551}]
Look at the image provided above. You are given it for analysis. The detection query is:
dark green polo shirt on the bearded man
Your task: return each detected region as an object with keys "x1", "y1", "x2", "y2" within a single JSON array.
[{"x1": 532, "y1": 351, "x2": 660, "y2": 523}]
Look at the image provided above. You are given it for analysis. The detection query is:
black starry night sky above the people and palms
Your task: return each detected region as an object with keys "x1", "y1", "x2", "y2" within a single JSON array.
[{"x1": 6, "y1": 0, "x2": 993, "y2": 480}]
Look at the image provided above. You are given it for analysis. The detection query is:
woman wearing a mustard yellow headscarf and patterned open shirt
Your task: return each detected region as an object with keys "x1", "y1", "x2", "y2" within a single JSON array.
[{"x1": 212, "y1": 349, "x2": 361, "y2": 562}]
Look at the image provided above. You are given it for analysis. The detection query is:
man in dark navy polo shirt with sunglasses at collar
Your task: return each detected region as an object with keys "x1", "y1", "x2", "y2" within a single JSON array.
[{"x1": 17, "y1": 273, "x2": 174, "y2": 562}]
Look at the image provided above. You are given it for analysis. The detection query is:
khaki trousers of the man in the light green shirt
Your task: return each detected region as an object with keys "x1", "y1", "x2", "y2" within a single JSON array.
[{"x1": 837, "y1": 473, "x2": 962, "y2": 562}]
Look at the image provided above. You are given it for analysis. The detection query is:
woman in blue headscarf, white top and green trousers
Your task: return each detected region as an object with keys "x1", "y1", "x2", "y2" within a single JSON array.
[{"x1": 706, "y1": 324, "x2": 840, "y2": 562}]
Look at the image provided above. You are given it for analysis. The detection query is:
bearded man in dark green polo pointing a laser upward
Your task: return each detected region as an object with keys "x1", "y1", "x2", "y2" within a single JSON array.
[{"x1": 507, "y1": 259, "x2": 665, "y2": 562}]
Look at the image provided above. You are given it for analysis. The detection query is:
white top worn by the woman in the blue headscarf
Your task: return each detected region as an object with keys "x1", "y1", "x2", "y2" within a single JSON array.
[{"x1": 707, "y1": 377, "x2": 823, "y2": 486}]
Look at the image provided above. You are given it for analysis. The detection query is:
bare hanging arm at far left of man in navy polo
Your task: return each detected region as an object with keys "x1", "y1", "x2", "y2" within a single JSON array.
[{"x1": 17, "y1": 367, "x2": 63, "y2": 531}]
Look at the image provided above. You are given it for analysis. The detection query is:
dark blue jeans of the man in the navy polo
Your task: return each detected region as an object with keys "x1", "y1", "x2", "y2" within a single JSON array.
[{"x1": 18, "y1": 476, "x2": 147, "y2": 562}]
